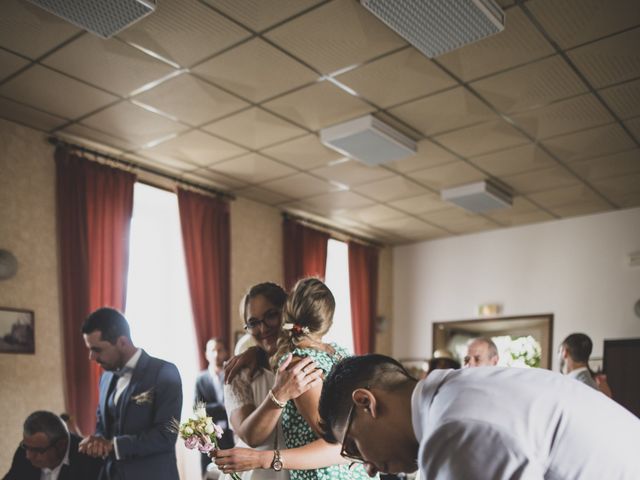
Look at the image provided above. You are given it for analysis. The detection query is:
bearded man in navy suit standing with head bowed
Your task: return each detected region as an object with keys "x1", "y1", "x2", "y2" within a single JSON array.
[{"x1": 80, "y1": 308, "x2": 182, "y2": 480}]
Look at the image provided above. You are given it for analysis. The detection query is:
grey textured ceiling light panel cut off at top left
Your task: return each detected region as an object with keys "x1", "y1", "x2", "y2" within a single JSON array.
[{"x1": 29, "y1": 0, "x2": 156, "y2": 38}]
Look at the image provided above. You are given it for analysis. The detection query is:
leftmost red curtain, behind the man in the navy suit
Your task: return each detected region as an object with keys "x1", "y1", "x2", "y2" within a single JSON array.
[{"x1": 55, "y1": 148, "x2": 136, "y2": 432}]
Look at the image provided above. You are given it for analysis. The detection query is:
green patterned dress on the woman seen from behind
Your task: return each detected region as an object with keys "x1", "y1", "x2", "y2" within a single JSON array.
[{"x1": 280, "y1": 343, "x2": 377, "y2": 480}]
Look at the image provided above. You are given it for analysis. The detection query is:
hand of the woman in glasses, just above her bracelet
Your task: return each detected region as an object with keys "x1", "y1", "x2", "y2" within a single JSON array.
[{"x1": 272, "y1": 354, "x2": 322, "y2": 402}]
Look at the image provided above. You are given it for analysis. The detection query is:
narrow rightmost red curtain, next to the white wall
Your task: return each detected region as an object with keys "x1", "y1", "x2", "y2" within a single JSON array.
[{"x1": 349, "y1": 242, "x2": 378, "y2": 355}]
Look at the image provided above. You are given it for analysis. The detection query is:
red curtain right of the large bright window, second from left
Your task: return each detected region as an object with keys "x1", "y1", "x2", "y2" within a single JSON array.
[{"x1": 178, "y1": 188, "x2": 231, "y2": 368}]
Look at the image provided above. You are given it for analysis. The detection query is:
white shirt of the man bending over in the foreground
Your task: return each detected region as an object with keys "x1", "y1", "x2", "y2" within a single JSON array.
[{"x1": 411, "y1": 367, "x2": 640, "y2": 480}]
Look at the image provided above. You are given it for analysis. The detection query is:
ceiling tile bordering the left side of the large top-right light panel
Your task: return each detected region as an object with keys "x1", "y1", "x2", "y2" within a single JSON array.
[{"x1": 266, "y1": 0, "x2": 406, "y2": 74}]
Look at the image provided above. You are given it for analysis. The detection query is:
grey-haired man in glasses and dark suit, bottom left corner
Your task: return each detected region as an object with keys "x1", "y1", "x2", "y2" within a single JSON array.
[{"x1": 4, "y1": 411, "x2": 102, "y2": 480}]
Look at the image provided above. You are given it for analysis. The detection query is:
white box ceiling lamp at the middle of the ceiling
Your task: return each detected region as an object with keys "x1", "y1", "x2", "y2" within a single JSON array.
[{"x1": 320, "y1": 115, "x2": 417, "y2": 165}]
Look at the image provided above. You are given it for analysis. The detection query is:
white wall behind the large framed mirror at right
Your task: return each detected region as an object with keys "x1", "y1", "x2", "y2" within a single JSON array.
[{"x1": 393, "y1": 208, "x2": 640, "y2": 368}]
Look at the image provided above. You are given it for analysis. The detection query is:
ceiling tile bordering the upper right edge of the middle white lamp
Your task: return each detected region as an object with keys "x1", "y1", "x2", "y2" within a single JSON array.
[{"x1": 389, "y1": 87, "x2": 496, "y2": 135}]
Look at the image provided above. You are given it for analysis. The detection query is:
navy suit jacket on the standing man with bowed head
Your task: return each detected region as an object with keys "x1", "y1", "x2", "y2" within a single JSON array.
[{"x1": 96, "y1": 351, "x2": 182, "y2": 480}]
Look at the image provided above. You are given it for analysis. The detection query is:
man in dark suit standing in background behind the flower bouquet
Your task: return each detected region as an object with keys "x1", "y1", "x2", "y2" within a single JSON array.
[{"x1": 195, "y1": 338, "x2": 234, "y2": 474}]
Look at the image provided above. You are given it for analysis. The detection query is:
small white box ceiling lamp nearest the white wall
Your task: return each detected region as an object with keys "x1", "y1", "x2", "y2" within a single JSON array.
[{"x1": 440, "y1": 180, "x2": 513, "y2": 213}]
